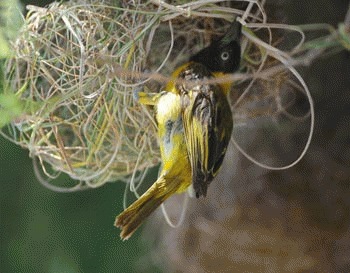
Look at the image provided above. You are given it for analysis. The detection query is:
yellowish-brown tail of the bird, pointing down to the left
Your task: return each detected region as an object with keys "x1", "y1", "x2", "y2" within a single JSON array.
[{"x1": 114, "y1": 175, "x2": 172, "y2": 240}]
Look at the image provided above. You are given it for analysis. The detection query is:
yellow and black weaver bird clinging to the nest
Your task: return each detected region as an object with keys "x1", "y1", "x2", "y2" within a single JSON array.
[{"x1": 115, "y1": 22, "x2": 241, "y2": 239}]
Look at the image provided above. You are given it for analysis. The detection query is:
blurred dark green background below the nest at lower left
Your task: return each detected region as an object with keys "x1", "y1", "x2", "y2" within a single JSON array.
[{"x1": 0, "y1": 137, "x2": 154, "y2": 273}]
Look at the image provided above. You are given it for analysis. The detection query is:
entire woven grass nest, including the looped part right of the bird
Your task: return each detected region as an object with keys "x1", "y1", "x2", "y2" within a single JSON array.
[{"x1": 3, "y1": 0, "x2": 313, "y2": 190}]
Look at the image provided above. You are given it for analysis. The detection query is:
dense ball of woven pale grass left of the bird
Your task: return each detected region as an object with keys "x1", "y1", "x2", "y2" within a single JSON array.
[{"x1": 2, "y1": 0, "x2": 246, "y2": 187}]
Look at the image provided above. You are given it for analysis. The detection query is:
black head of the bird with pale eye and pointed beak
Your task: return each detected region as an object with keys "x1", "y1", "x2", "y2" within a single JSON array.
[{"x1": 190, "y1": 21, "x2": 242, "y2": 73}]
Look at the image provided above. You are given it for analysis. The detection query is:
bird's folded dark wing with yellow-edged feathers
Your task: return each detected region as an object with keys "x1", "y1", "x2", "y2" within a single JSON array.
[{"x1": 182, "y1": 84, "x2": 232, "y2": 198}]
